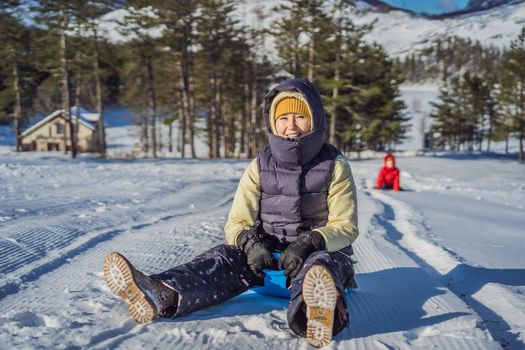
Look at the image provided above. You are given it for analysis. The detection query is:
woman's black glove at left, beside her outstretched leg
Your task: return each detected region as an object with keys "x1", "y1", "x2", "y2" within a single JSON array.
[{"x1": 235, "y1": 228, "x2": 277, "y2": 278}]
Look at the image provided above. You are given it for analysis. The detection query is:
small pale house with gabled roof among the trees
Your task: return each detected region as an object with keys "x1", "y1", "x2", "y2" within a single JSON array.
[{"x1": 21, "y1": 107, "x2": 99, "y2": 152}]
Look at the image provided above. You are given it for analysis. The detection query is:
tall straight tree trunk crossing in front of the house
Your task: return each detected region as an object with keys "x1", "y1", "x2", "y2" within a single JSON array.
[{"x1": 59, "y1": 9, "x2": 77, "y2": 158}]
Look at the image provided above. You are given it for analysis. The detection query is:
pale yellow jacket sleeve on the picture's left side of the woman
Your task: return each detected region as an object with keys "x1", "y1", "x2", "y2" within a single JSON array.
[{"x1": 224, "y1": 159, "x2": 261, "y2": 245}]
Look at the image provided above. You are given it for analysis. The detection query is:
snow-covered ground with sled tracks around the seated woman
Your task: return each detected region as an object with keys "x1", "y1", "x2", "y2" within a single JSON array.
[{"x1": 0, "y1": 153, "x2": 525, "y2": 349}]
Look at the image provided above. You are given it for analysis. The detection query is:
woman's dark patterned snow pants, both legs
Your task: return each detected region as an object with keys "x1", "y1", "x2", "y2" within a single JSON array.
[{"x1": 150, "y1": 244, "x2": 354, "y2": 336}]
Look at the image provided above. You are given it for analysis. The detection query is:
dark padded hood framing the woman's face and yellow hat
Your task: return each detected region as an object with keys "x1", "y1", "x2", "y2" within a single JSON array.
[{"x1": 263, "y1": 78, "x2": 326, "y2": 168}]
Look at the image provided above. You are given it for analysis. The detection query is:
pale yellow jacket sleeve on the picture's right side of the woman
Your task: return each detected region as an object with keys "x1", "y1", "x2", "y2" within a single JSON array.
[{"x1": 314, "y1": 156, "x2": 359, "y2": 252}]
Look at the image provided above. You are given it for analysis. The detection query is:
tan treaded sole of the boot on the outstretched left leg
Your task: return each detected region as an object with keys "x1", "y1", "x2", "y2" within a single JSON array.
[{"x1": 103, "y1": 252, "x2": 157, "y2": 323}]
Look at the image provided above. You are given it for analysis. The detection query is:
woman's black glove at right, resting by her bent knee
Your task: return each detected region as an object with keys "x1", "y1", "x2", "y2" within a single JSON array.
[{"x1": 278, "y1": 231, "x2": 326, "y2": 278}]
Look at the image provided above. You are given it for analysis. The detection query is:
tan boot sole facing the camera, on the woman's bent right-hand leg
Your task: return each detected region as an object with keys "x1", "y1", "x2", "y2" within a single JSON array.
[{"x1": 303, "y1": 265, "x2": 337, "y2": 347}]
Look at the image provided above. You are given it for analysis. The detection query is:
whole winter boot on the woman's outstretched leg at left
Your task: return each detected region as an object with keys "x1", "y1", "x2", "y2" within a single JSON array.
[{"x1": 103, "y1": 252, "x2": 178, "y2": 323}]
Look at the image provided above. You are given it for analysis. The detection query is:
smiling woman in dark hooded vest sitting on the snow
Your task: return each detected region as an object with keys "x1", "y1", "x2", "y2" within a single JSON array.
[{"x1": 104, "y1": 79, "x2": 359, "y2": 346}]
